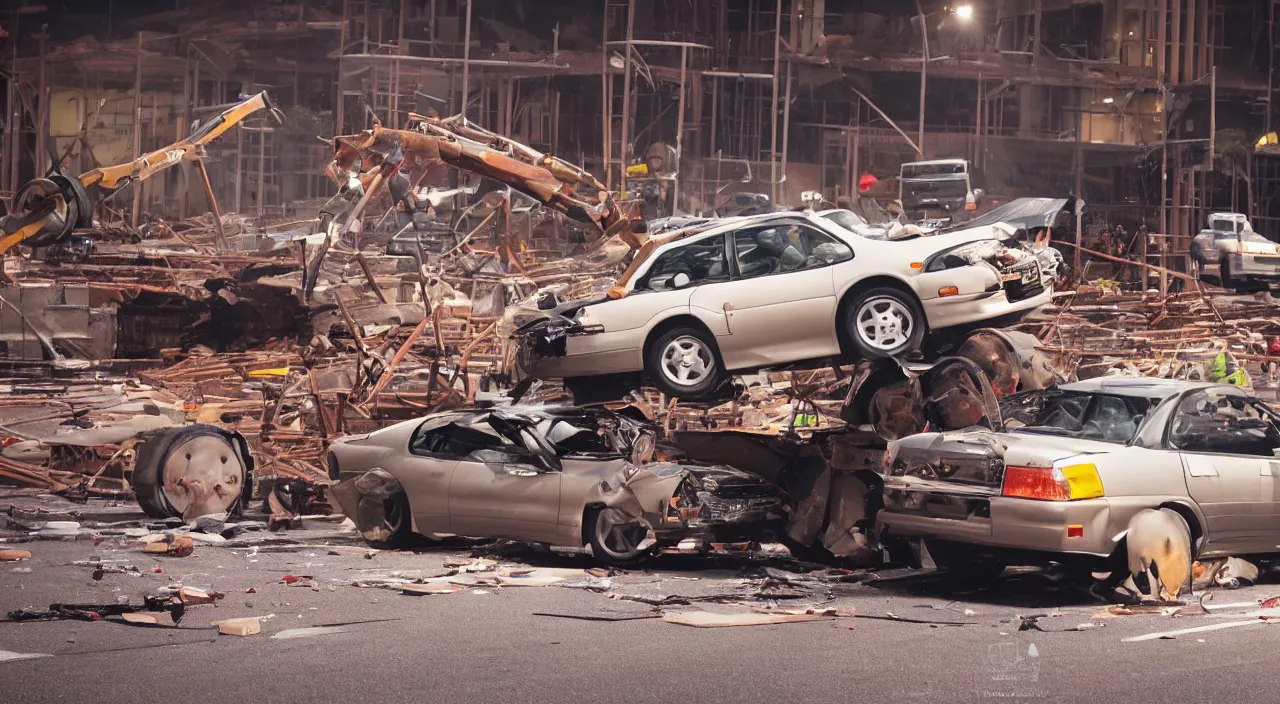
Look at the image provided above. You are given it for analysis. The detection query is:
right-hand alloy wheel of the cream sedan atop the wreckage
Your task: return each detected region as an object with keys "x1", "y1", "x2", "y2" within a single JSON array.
[{"x1": 844, "y1": 287, "x2": 925, "y2": 360}]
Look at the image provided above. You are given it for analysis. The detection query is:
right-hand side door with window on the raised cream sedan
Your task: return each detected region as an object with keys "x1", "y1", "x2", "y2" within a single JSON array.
[{"x1": 689, "y1": 221, "x2": 852, "y2": 369}]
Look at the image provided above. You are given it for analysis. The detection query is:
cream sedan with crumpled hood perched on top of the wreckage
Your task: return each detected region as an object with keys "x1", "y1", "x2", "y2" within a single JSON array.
[{"x1": 515, "y1": 211, "x2": 1052, "y2": 398}]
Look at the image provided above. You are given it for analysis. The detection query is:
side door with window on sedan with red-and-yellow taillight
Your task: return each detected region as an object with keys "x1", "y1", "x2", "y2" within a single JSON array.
[{"x1": 1169, "y1": 387, "x2": 1280, "y2": 553}]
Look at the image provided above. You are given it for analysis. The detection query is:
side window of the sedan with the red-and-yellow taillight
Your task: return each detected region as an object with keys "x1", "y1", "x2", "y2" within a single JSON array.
[{"x1": 1169, "y1": 389, "x2": 1280, "y2": 458}]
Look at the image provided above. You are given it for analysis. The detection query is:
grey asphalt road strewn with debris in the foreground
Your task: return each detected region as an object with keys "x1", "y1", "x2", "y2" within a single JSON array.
[{"x1": 0, "y1": 531, "x2": 1280, "y2": 704}]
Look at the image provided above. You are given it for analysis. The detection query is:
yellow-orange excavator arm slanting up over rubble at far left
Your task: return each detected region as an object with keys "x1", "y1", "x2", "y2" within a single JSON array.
[{"x1": 0, "y1": 92, "x2": 280, "y2": 257}]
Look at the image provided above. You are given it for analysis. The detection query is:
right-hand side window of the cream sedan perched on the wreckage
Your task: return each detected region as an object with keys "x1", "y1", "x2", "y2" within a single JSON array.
[{"x1": 733, "y1": 223, "x2": 854, "y2": 279}]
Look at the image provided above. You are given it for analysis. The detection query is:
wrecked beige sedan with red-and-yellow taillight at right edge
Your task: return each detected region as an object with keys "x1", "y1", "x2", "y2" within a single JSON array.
[{"x1": 876, "y1": 379, "x2": 1280, "y2": 578}]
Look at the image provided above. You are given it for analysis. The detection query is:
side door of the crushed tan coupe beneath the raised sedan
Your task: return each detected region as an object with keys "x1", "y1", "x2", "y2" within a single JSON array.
[{"x1": 448, "y1": 412, "x2": 562, "y2": 541}]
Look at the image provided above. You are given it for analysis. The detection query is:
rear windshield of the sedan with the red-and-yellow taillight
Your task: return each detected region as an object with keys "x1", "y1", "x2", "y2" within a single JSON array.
[{"x1": 1001, "y1": 389, "x2": 1153, "y2": 444}]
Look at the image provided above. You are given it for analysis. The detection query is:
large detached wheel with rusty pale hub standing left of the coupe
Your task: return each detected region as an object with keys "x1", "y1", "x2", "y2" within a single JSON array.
[{"x1": 131, "y1": 424, "x2": 253, "y2": 518}]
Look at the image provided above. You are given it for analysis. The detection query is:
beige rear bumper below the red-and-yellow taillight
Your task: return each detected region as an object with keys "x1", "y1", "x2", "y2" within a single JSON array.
[{"x1": 876, "y1": 497, "x2": 1128, "y2": 558}]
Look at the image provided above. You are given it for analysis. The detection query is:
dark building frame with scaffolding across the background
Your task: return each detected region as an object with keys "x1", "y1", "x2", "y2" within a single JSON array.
[{"x1": 0, "y1": 0, "x2": 1280, "y2": 262}]
